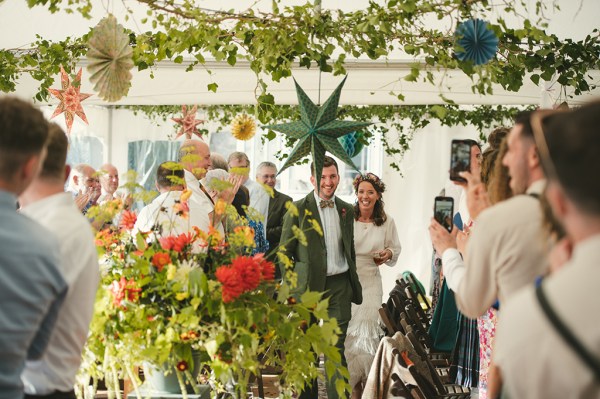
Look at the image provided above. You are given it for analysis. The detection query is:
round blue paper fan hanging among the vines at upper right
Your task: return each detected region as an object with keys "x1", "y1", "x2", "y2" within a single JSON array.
[{"x1": 455, "y1": 19, "x2": 498, "y2": 65}]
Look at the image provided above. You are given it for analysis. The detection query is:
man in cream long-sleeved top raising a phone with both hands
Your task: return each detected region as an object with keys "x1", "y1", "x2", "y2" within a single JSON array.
[{"x1": 429, "y1": 113, "x2": 547, "y2": 318}]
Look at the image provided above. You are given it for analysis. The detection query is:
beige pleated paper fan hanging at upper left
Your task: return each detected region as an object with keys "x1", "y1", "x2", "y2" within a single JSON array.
[{"x1": 87, "y1": 15, "x2": 133, "y2": 101}]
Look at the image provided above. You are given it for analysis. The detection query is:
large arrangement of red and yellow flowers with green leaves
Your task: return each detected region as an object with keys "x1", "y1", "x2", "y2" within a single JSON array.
[{"x1": 80, "y1": 186, "x2": 348, "y2": 397}]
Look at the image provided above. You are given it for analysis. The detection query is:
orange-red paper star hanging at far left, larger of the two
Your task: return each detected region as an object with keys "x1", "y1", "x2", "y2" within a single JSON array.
[{"x1": 48, "y1": 65, "x2": 93, "y2": 133}]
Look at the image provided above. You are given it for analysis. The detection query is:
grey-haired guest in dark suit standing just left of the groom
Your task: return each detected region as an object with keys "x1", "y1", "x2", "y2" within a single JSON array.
[{"x1": 256, "y1": 161, "x2": 292, "y2": 272}]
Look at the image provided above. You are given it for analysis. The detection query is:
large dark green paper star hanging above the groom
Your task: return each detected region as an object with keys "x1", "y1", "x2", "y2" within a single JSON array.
[{"x1": 263, "y1": 76, "x2": 371, "y2": 192}]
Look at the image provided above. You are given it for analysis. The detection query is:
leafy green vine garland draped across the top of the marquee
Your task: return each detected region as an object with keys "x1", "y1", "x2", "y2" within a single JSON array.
[{"x1": 0, "y1": 0, "x2": 600, "y2": 105}]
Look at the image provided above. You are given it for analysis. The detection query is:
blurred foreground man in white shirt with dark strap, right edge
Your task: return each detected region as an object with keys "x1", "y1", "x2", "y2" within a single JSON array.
[{"x1": 494, "y1": 101, "x2": 600, "y2": 399}]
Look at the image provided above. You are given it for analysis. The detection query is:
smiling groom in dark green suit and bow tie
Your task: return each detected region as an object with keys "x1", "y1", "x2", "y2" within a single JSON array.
[{"x1": 280, "y1": 156, "x2": 362, "y2": 399}]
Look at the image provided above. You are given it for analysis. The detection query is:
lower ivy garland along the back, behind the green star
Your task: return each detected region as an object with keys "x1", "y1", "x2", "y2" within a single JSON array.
[{"x1": 115, "y1": 104, "x2": 535, "y2": 171}]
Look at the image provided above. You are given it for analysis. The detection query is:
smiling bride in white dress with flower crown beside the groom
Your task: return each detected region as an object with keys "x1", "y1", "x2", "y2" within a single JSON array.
[{"x1": 345, "y1": 173, "x2": 400, "y2": 399}]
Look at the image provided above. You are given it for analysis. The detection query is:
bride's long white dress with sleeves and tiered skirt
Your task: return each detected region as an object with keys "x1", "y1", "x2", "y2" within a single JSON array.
[{"x1": 345, "y1": 215, "x2": 400, "y2": 386}]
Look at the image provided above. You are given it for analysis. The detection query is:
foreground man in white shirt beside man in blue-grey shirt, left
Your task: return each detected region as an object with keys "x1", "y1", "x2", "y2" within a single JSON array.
[{"x1": 19, "y1": 124, "x2": 100, "y2": 398}]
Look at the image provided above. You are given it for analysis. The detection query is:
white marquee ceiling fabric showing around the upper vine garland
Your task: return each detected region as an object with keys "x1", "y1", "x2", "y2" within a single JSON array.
[{"x1": 0, "y1": 0, "x2": 600, "y2": 105}]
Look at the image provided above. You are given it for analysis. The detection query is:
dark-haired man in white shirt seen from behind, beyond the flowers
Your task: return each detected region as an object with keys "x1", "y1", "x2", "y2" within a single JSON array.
[{"x1": 133, "y1": 162, "x2": 209, "y2": 237}]
